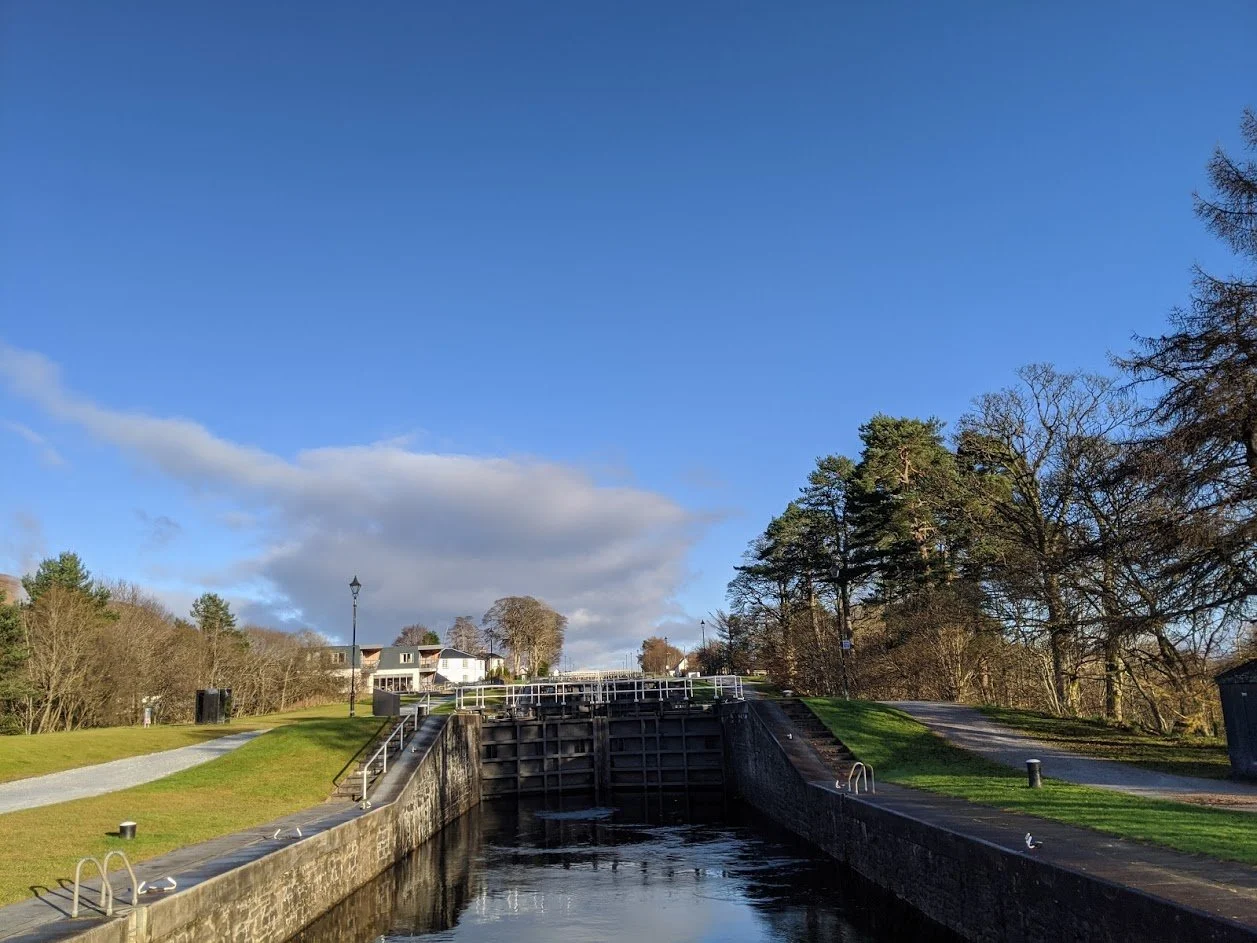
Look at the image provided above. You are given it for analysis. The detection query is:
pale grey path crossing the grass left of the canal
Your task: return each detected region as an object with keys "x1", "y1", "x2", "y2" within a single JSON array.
[{"x1": 0, "y1": 731, "x2": 265, "y2": 813}]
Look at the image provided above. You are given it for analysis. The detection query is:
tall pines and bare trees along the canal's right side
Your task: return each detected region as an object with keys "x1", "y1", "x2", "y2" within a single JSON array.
[{"x1": 716, "y1": 111, "x2": 1257, "y2": 733}]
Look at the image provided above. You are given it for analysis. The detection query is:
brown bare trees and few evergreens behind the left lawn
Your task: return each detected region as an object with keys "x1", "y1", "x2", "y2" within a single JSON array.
[{"x1": 0, "y1": 552, "x2": 342, "y2": 733}]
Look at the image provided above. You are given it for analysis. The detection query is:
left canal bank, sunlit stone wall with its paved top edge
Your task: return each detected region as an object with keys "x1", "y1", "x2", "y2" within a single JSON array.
[{"x1": 0, "y1": 717, "x2": 480, "y2": 943}]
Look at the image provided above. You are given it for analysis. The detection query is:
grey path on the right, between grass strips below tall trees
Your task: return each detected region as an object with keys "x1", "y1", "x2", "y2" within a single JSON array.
[{"x1": 891, "y1": 700, "x2": 1257, "y2": 812}]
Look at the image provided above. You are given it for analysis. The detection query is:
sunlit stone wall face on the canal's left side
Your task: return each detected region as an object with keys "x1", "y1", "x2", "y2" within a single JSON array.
[{"x1": 79, "y1": 717, "x2": 480, "y2": 943}]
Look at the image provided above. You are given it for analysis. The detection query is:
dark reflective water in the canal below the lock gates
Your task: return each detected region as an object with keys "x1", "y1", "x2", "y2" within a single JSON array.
[{"x1": 292, "y1": 793, "x2": 955, "y2": 943}]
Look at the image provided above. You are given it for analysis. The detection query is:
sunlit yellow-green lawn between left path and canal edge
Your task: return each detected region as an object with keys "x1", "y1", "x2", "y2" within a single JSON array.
[{"x1": 0, "y1": 704, "x2": 388, "y2": 904}]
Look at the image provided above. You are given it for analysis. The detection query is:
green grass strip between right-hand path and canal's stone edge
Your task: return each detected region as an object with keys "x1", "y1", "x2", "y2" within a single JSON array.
[{"x1": 807, "y1": 698, "x2": 1257, "y2": 864}]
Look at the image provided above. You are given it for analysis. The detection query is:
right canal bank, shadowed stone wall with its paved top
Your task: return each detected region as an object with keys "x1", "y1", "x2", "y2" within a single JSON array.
[{"x1": 723, "y1": 702, "x2": 1257, "y2": 943}]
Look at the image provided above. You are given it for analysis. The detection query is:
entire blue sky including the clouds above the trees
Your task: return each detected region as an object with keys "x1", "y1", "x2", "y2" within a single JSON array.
[{"x1": 0, "y1": 0, "x2": 1257, "y2": 661}]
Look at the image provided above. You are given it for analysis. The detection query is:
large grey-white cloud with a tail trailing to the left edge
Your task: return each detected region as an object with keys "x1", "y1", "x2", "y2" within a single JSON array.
[{"x1": 0, "y1": 345, "x2": 700, "y2": 664}]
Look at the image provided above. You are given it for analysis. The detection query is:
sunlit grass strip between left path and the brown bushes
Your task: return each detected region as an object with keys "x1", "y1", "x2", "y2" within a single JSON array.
[{"x1": 0, "y1": 702, "x2": 356, "y2": 782}]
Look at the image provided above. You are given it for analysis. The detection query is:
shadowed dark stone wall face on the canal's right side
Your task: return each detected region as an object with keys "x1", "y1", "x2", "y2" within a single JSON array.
[{"x1": 724, "y1": 704, "x2": 1254, "y2": 943}]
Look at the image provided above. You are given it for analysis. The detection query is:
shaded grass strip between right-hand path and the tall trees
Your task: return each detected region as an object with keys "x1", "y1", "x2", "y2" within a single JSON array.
[{"x1": 979, "y1": 707, "x2": 1231, "y2": 780}]
